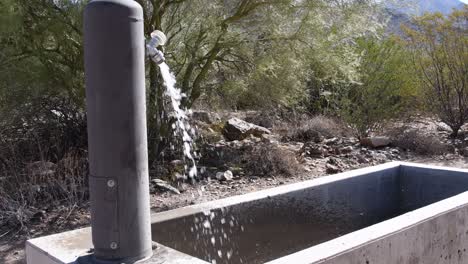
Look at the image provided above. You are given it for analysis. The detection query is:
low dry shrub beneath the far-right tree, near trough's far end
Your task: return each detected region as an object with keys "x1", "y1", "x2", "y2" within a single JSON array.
[{"x1": 392, "y1": 129, "x2": 449, "y2": 155}]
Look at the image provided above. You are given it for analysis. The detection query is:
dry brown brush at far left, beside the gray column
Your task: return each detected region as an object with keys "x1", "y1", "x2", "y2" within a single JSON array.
[{"x1": 0, "y1": 152, "x2": 88, "y2": 230}]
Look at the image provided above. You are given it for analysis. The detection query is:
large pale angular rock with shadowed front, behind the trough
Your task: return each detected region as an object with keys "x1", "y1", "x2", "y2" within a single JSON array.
[{"x1": 223, "y1": 118, "x2": 271, "y2": 141}]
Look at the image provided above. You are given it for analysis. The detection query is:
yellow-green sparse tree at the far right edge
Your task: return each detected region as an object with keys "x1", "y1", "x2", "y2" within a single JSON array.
[{"x1": 404, "y1": 6, "x2": 468, "y2": 137}]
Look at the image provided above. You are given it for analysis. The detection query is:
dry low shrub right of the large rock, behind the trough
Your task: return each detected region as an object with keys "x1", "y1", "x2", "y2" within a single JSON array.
[{"x1": 275, "y1": 115, "x2": 349, "y2": 142}]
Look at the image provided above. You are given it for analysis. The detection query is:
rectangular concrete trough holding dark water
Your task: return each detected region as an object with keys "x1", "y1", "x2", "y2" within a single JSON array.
[{"x1": 27, "y1": 162, "x2": 468, "y2": 264}]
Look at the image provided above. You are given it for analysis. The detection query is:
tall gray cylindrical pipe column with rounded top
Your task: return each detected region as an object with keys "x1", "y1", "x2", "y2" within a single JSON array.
[{"x1": 84, "y1": 0, "x2": 152, "y2": 263}]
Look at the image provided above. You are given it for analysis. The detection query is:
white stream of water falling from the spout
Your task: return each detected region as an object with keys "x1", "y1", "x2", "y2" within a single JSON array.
[{"x1": 159, "y1": 62, "x2": 197, "y2": 179}]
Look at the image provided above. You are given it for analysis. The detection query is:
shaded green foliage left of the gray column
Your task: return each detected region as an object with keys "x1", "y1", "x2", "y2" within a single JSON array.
[{"x1": 0, "y1": 0, "x2": 86, "y2": 164}]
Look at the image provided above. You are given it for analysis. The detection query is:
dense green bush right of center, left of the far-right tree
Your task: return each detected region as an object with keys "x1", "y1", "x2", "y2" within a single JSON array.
[{"x1": 341, "y1": 38, "x2": 417, "y2": 137}]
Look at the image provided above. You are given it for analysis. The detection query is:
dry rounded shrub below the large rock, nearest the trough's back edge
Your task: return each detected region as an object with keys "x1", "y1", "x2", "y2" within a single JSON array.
[{"x1": 243, "y1": 143, "x2": 300, "y2": 176}]
